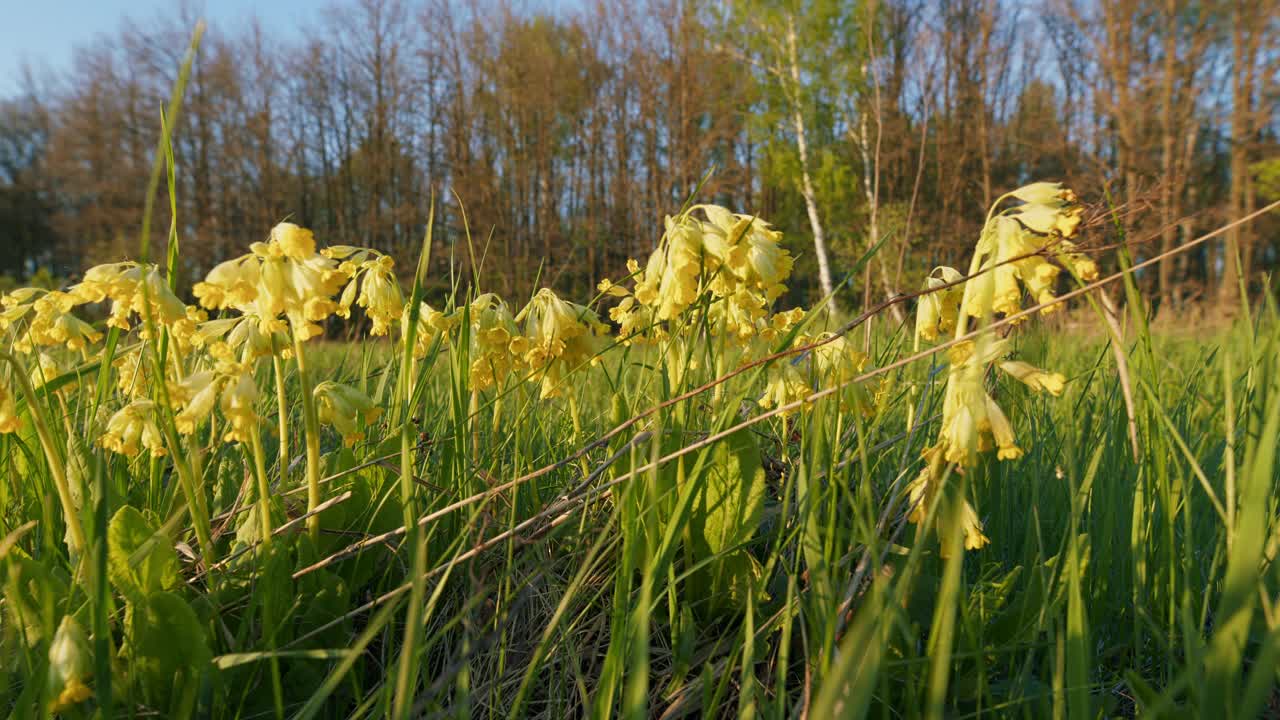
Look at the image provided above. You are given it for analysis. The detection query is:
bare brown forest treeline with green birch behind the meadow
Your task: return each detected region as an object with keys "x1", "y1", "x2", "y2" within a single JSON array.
[{"x1": 0, "y1": 0, "x2": 1280, "y2": 307}]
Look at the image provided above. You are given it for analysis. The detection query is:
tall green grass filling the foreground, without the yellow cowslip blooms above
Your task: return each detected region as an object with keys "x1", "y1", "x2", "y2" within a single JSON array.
[{"x1": 0, "y1": 32, "x2": 1280, "y2": 717}]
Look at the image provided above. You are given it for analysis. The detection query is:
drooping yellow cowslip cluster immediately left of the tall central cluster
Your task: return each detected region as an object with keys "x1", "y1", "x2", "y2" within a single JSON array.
[{"x1": 511, "y1": 287, "x2": 608, "y2": 398}]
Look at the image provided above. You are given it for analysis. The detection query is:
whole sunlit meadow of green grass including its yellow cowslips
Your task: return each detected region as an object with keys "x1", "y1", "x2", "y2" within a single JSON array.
[{"x1": 0, "y1": 46, "x2": 1280, "y2": 719}]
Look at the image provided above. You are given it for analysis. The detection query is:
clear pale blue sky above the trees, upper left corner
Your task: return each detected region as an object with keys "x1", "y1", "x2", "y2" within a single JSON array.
[{"x1": 0, "y1": 0, "x2": 320, "y2": 96}]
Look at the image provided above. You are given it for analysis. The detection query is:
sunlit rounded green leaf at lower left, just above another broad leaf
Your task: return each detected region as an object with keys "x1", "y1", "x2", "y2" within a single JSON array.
[{"x1": 106, "y1": 506, "x2": 179, "y2": 605}]
